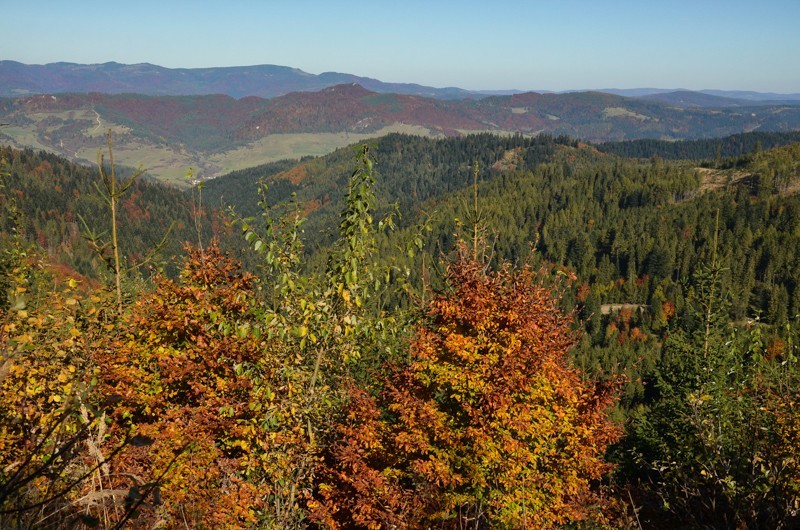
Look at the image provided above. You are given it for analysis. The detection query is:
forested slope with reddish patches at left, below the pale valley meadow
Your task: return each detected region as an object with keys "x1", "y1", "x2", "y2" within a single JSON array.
[{"x1": 0, "y1": 147, "x2": 238, "y2": 278}]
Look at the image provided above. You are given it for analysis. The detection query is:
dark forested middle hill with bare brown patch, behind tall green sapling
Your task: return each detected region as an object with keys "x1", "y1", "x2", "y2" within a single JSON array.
[{"x1": 206, "y1": 133, "x2": 577, "y2": 249}]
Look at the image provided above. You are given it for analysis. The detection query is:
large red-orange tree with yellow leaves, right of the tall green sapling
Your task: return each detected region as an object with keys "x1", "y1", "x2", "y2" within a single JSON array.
[{"x1": 313, "y1": 244, "x2": 619, "y2": 528}]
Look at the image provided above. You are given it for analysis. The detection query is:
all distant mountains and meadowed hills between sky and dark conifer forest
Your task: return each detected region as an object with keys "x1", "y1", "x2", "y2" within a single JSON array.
[{"x1": 0, "y1": 61, "x2": 800, "y2": 182}]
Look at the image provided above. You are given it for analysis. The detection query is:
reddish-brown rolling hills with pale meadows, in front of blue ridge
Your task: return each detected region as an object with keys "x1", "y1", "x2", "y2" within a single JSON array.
[{"x1": 0, "y1": 84, "x2": 800, "y2": 184}]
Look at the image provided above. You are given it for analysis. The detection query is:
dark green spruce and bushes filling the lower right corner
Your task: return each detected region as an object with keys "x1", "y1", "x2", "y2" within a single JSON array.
[{"x1": 625, "y1": 245, "x2": 800, "y2": 527}]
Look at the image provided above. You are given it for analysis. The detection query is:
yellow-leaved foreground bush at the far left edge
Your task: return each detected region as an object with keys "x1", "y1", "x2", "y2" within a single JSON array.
[{"x1": 0, "y1": 253, "x2": 99, "y2": 528}]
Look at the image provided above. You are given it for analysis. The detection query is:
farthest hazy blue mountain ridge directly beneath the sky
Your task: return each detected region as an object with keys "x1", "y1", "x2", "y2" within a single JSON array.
[{"x1": 0, "y1": 60, "x2": 800, "y2": 107}]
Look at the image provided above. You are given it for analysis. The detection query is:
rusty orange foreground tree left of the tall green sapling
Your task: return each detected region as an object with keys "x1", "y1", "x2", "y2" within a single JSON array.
[{"x1": 95, "y1": 242, "x2": 261, "y2": 527}]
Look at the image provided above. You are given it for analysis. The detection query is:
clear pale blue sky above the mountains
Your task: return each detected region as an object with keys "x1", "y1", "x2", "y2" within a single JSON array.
[{"x1": 6, "y1": 0, "x2": 800, "y2": 93}]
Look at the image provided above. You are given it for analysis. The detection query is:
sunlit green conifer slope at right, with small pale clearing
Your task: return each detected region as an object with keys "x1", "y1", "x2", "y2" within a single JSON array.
[{"x1": 396, "y1": 139, "x2": 800, "y2": 404}]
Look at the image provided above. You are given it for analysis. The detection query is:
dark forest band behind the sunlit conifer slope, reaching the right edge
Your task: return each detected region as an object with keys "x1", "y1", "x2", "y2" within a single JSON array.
[{"x1": 205, "y1": 132, "x2": 800, "y2": 254}]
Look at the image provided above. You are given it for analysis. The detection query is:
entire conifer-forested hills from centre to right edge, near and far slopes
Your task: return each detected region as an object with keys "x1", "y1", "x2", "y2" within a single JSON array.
[{"x1": 206, "y1": 134, "x2": 800, "y2": 392}]
